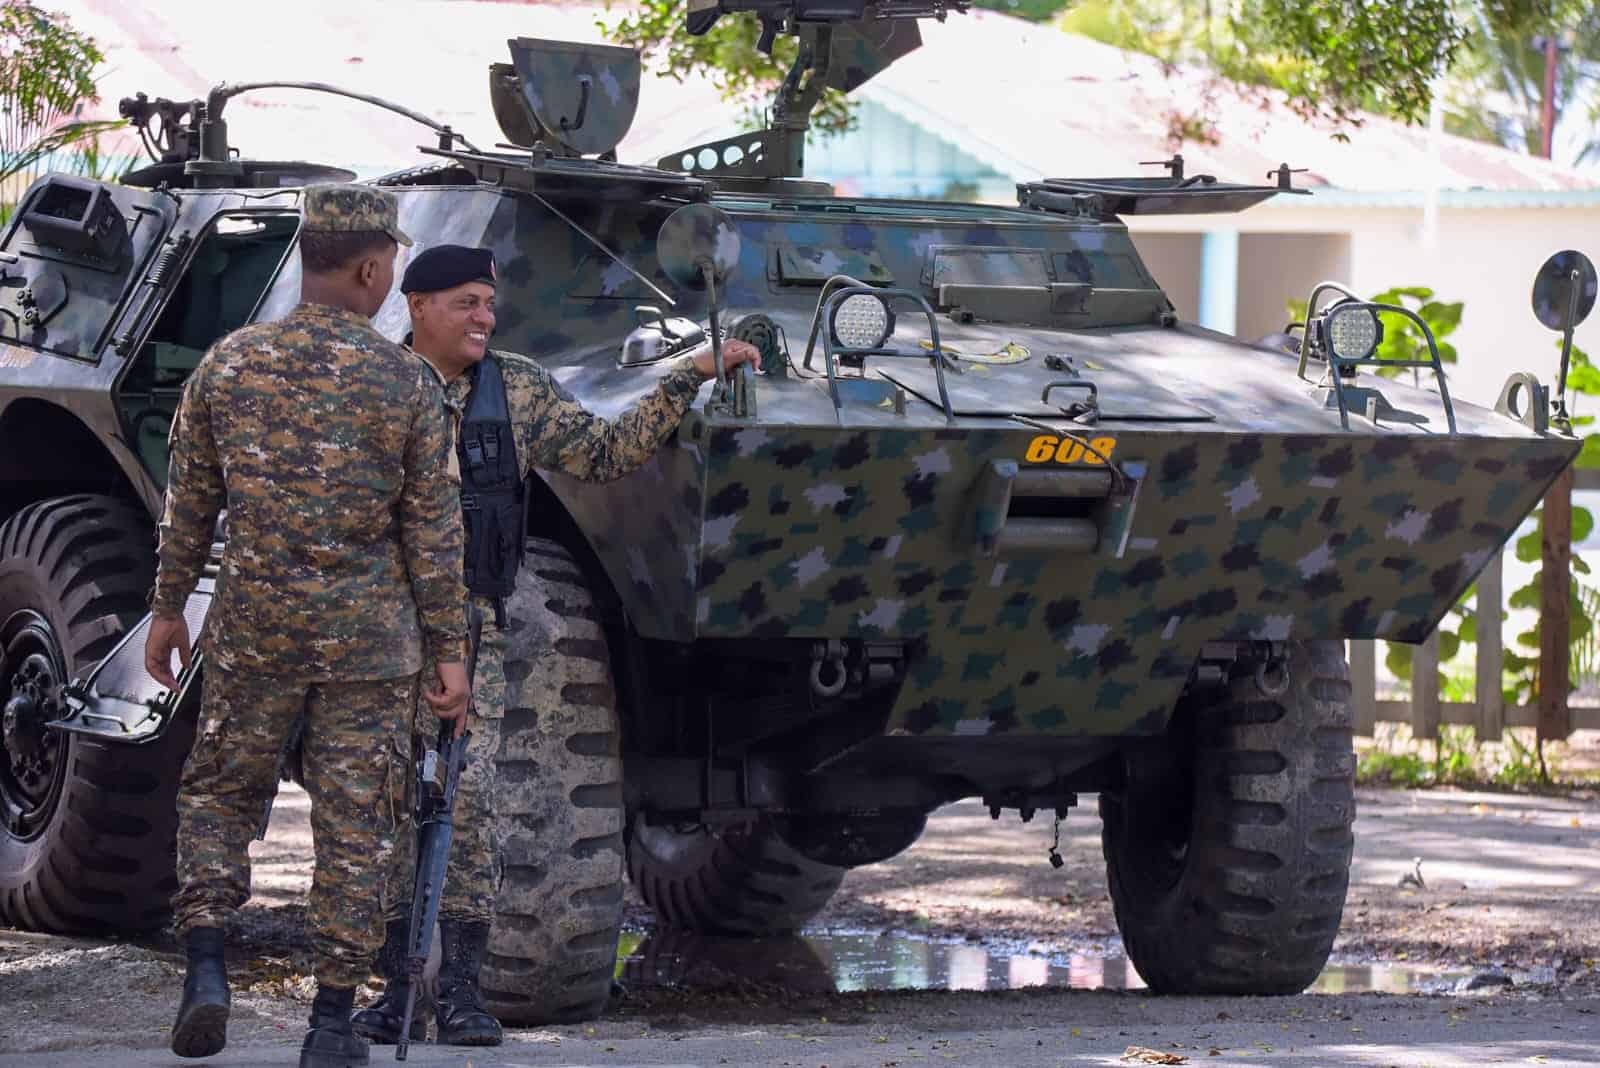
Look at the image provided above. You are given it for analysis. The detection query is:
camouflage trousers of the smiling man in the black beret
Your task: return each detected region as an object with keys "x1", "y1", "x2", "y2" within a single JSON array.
[{"x1": 384, "y1": 600, "x2": 506, "y2": 923}]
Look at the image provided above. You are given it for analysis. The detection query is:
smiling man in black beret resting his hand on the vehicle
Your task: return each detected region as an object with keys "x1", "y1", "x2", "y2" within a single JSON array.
[{"x1": 355, "y1": 245, "x2": 758, "y2": 1046}]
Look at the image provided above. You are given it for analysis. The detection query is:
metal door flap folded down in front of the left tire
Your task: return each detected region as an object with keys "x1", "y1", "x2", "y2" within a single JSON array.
[{"x1": 50, "y1": 577, "x2": 214, "y2": 745}]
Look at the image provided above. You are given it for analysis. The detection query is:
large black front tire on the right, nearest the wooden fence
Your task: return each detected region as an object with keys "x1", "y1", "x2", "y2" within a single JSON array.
[{"x1": 1101, "y1": 641, "x2": 1355, "y2": 994}]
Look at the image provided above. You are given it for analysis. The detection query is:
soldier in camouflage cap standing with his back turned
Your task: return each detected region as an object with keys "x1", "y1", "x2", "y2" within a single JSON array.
[{"x1": 146, "y1": 185, "x2": 467, "y2": 1068}]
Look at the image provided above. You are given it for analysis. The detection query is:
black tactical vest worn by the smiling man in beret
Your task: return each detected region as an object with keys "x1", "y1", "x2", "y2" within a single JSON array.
[{"x1": 456, "y1": 353, "x2": 528, "y2": 625}]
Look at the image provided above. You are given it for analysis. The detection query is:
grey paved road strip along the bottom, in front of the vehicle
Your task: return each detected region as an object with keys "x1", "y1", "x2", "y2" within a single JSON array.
[{"x1": 0, "y1": 991, "x2": 1600, "y2": 1068}]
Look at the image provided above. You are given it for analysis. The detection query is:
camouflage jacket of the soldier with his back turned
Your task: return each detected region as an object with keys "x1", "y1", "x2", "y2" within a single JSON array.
[{"x1": 150, "y1": 304, "x2": 466, "y2": 681}]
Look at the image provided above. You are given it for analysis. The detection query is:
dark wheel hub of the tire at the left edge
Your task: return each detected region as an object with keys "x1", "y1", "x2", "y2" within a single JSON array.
[{"x1": 0, "y1": 611, "x2": 66, "y2": 836}]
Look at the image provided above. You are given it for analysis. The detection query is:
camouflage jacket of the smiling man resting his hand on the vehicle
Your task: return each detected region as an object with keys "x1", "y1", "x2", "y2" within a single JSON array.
[{"x1": 445, "y1": 352, "x2": 706, "y2": 483}]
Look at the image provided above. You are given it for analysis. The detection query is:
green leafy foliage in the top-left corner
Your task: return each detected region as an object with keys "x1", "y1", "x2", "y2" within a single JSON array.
[{"x1": 0, "y1": 0, "x2": 114, "y2": 187}]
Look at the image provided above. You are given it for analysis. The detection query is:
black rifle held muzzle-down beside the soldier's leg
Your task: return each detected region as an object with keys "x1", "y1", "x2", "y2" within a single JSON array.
[{"x1": 395, "y1": 606, "x2": 483, "y2": 1060}]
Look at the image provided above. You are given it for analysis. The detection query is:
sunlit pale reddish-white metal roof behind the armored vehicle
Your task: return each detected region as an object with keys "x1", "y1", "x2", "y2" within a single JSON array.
[{"x1": 56, "y1": 0, "x2": 1600, "y2": 195}]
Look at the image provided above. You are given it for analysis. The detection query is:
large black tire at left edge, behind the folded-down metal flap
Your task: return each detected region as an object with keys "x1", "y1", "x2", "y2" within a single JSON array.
[{"x1": 0, "y1": 496, "x2": 192, "y2": 931}]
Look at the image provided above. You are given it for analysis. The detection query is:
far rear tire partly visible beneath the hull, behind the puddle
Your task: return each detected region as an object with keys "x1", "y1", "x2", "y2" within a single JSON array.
[{"x1": 627, "y1": 814, "x2": 845, "y2": 937}]
